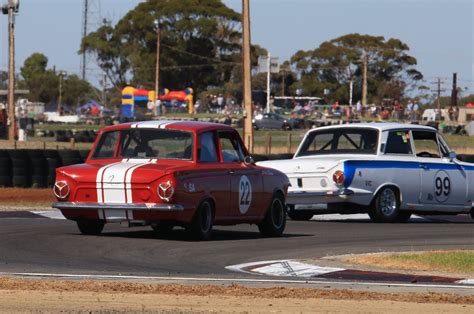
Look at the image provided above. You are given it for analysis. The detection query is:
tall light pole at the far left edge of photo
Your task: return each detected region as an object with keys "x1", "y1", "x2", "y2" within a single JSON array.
[{"x1": 7, "y1": 1, "x2": 15, "y2": 141}]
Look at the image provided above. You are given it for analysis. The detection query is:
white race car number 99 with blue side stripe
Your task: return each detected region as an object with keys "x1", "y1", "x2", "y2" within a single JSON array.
[{"x1": 258, "y1": 123, "x2": 474, "y2": 222}]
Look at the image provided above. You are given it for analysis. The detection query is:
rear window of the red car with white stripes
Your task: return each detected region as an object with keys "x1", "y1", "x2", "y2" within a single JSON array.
[{"x1": 92, "y1": 129, "x2": 193, "y2": 160}]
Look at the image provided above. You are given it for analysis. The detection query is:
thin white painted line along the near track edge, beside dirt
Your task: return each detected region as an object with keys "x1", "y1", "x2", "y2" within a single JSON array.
[{"x1": 0, "y1": 272, "x2": 474, "y2": 290}]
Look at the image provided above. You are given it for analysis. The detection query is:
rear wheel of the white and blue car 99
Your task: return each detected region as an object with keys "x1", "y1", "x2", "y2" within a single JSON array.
[{"x1": 369, "y1": 186, "x2": 404, "y2": 223}]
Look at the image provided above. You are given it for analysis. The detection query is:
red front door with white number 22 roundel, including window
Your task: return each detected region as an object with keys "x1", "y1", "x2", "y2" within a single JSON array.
[{"x1": 218, "y1": 131, "x2": 263, "y2": 221}]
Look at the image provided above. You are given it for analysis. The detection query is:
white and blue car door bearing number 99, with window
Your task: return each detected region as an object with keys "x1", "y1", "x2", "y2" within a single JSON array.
[{"x1": 412, "y1": 130, "x2": 469, "y2": 210}]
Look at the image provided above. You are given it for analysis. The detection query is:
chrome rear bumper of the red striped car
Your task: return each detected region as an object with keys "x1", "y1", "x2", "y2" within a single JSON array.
[{"x1": 51, "y1": 202, "x2": 185, "y2": 212}]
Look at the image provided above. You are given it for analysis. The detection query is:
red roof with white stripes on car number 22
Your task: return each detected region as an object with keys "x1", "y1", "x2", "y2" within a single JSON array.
[{"x1": 101, "y1": 120, "x2": 234, "y2": 132}]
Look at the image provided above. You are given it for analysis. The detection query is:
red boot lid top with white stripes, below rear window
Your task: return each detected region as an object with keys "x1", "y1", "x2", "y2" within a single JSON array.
[{"x1": 59, "y1": 160, "x2": 184, "y2": 184}]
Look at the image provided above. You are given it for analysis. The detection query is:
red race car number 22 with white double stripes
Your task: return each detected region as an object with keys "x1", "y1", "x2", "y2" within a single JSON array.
[{"x1": 52, "y1": 121, "x2": 289, "y2": 240}]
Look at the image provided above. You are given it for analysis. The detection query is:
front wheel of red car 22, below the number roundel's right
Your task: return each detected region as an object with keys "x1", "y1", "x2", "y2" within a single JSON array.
[{"x1": 258, "y1": 194, "x2": 286, "y2": 237}]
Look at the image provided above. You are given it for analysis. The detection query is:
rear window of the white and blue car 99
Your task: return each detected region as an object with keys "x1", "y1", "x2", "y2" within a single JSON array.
[{"x1": 297, "y1": 128, "x2": 378, "y2": 157}]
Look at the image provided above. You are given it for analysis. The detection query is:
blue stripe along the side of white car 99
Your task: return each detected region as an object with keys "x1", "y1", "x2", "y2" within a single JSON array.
[{"x1": 344, "y1": 160, "x2": 474, "y2": 188}]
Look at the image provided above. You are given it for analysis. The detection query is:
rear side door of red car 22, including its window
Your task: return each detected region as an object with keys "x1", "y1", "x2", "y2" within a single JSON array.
[{"x1": 195, "y1": 132, "x2": 231, "y2": 219}]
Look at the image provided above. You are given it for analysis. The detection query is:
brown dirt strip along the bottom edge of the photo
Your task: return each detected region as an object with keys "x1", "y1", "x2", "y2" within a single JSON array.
[{"x1": 0, "y1": 278, "x2": 474, "y2": 313}]
